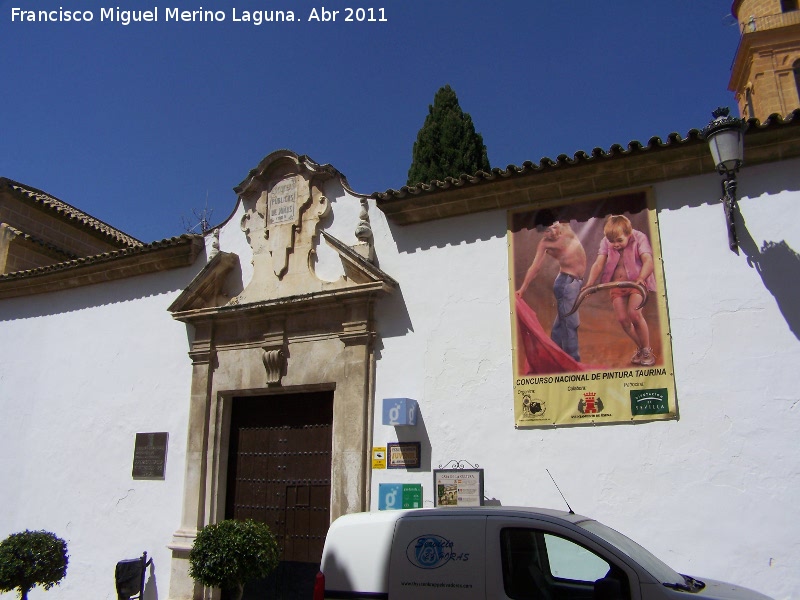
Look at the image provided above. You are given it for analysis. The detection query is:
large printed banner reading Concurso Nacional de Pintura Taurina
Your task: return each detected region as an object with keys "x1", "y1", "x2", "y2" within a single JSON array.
[{"x1": 508, "y1": 192, "x2": 678, "y2": 427}]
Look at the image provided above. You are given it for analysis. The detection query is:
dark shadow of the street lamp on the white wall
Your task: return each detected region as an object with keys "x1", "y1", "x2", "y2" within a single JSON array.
[{"x1": 736, "y1": 213, "x2": 800, "y2": 339}]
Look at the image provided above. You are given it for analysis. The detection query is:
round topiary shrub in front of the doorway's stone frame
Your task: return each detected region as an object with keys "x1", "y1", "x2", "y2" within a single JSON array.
[{"x1": 189, "y1": 519, "x2": 278, "y2": 600}]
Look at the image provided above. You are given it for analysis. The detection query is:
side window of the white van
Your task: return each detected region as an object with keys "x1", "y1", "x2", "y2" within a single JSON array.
[{"x1": 500, "y1": 527, "x2": 630, "y2": 600}]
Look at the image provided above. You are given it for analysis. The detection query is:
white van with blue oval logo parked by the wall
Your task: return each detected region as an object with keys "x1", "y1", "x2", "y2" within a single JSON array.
[{"x1": 314, "y1": 506, "x2": 770, "y2": 600}]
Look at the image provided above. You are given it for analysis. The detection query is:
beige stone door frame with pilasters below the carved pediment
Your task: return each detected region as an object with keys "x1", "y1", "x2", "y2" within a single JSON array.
[{"x1": 169, "y1": 282, "x2": 387, "y2": 600}]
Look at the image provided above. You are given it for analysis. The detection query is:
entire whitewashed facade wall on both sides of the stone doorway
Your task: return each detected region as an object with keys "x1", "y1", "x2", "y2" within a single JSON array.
[{"x1": 0, "y1": 160, "x2": 800, "y2": 600}]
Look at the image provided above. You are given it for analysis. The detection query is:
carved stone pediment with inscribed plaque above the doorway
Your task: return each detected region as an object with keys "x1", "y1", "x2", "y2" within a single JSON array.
[{"x1": 169, "y1": 150, "x2": 397, "y2": 320}]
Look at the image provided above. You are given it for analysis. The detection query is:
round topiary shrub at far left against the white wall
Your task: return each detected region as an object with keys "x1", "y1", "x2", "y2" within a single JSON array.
[{"x1": 0, "y1": 529, "x2": 69, "y2": 600}]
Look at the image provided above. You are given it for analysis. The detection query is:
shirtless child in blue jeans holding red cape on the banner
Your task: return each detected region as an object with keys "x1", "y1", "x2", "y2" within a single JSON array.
[{"x1": 516, "y1": 210, "x2": 586, "y2": 362}]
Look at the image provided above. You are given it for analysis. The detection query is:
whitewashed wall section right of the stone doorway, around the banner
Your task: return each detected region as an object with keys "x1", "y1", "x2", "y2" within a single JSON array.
[{"x1": 372, "y1": 161, "x2": 800, "y2": 598}]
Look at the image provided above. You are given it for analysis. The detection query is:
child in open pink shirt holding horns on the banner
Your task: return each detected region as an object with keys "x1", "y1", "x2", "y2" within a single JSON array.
[{"x1": 584, "y1": 215, "x2": 656, "y2": 367}]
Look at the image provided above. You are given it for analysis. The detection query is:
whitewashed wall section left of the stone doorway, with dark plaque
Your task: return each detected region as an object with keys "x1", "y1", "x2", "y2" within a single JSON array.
[{"x1": 0, "y1": 268, "x2": 202, "y2": 600}]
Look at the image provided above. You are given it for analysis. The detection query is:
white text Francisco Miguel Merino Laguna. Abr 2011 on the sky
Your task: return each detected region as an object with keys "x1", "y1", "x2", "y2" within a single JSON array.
[{"x1": 11, "y1": 6, "x2": 389, "y2": 25}]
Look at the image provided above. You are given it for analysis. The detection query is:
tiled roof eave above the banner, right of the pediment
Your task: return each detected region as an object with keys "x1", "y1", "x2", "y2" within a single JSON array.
[{"x1": 372, "y1": 109, "x2": 800, "y2": 225}]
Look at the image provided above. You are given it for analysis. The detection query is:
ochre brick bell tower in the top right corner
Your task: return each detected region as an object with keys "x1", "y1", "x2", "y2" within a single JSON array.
[{"x1": 728, "y1": 0, "x2": 800, "y2": 122}]
